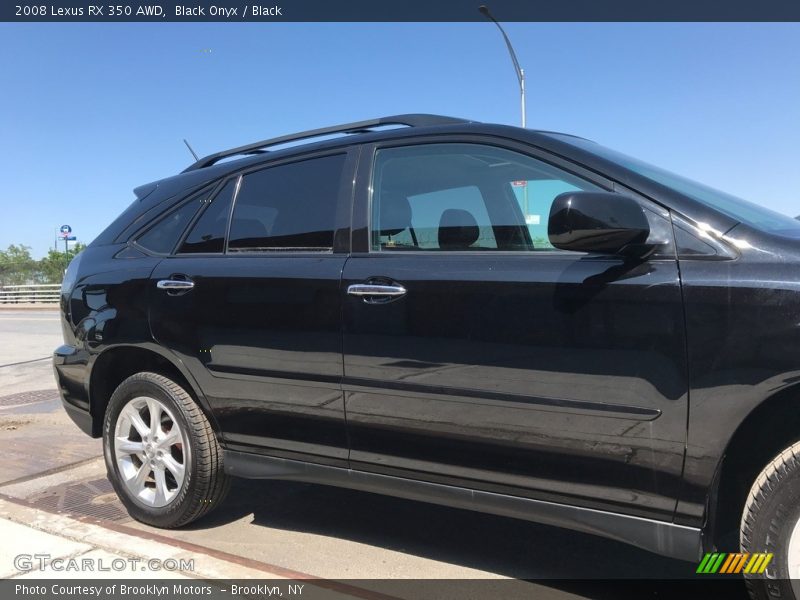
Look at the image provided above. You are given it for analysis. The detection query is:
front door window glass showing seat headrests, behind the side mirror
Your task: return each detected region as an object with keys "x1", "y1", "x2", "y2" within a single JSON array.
[{"x1": 371, "y1": 143, "x2": 602, "y2": 251}]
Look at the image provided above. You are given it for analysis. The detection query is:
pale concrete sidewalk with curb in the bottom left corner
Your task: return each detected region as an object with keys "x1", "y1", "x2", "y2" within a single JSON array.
[{"x1": 0, "y1": 494, "x2": 410, "y2": 600}]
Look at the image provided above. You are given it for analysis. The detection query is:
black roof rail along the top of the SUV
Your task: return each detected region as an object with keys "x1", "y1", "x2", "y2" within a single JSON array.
[{"x1": 183, "y1": 114, "x2": 470, "y2": 173}]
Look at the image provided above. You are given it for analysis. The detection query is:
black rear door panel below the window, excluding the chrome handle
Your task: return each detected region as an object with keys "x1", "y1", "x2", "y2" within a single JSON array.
[{"x1": 149, "y1": 254, "x2": 347, "y2": 464}]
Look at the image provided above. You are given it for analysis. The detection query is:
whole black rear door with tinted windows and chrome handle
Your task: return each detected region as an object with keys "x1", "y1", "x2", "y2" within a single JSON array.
[{"x1": 150, "y1": 151, "x2": 355, "y2": 465}]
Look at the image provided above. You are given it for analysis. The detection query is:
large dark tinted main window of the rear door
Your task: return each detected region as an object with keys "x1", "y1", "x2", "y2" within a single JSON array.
[{"x1": 228, "y1": 154, "x2": 345, "y2": 252}]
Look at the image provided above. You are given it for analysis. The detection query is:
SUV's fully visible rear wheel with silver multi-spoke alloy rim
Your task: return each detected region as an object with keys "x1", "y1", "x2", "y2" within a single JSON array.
[{"x1": 103, "y1": 372, "x2": 230, "y2": 528}]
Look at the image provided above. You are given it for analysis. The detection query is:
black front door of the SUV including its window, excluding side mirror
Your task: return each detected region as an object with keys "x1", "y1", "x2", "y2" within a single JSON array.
[{"x1": 342, "y1": 138, "x2": 687, "y2": 519}]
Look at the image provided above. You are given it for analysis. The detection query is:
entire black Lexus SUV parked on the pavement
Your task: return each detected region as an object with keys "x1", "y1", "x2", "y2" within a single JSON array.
[{"x1": 54, "y1": 115, "x2": 800, "y2": 597}]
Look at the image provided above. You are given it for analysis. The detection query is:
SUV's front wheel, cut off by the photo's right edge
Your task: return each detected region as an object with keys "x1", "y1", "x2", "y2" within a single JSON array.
[{"x1": 740, "y1": 442, "x2": 800, "y2": 600}]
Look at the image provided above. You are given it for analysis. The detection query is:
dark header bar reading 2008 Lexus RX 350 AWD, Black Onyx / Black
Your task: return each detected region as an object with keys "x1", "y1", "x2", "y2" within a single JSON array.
[{"x1": 0, "y1": 0, "x2": 800, "y2": 23}]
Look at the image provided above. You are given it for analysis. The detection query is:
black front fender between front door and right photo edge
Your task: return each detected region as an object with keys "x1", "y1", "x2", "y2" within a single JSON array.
[{"x1": 676, "y1": 228, "x2": 800, "y2": 525}]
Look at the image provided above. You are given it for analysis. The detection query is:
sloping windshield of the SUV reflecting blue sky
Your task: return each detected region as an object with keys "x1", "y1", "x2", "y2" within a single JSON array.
[{"x1": 548, "y1": 134, "x2": 800, "y2": 238}]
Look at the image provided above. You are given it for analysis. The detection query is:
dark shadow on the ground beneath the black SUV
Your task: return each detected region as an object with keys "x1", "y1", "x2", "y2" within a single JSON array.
[{"x1": 181, "y1": 479, "x2": 747, "y2": 600}]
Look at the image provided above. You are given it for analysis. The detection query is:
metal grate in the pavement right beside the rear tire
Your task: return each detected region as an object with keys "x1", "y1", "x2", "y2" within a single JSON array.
[{"x1": 30, "y1": 479, "x2": 131, "y2": 523}]
